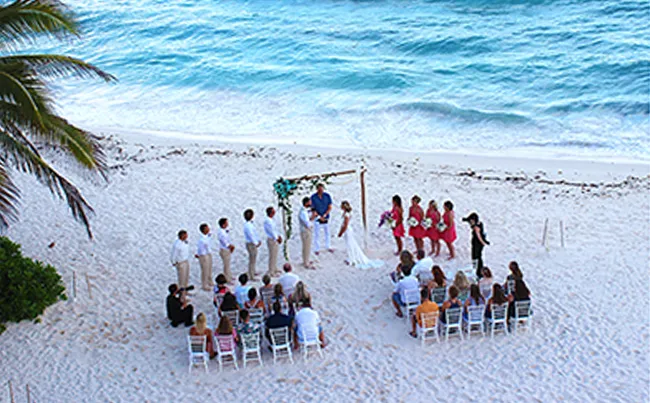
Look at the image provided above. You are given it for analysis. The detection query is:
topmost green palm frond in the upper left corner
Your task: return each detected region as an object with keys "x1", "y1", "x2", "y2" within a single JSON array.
[{"x1": 0, "y1": 0, "x2": 78, "y2": 47}]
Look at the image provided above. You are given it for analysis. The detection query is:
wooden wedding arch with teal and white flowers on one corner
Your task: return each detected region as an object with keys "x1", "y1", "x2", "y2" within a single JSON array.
[{"x1": 273, "y1": 166, "x2": 368, "y2": 260}]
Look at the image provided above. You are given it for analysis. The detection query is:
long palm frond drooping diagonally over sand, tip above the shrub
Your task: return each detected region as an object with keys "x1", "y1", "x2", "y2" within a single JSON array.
[{"x1": 0, "y1": 122, "x2": 93, "y2": 238}]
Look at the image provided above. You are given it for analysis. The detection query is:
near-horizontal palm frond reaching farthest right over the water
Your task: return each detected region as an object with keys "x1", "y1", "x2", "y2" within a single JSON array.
[{"x1": 0, "y1": 55, "x2": 116, "y2": 82}]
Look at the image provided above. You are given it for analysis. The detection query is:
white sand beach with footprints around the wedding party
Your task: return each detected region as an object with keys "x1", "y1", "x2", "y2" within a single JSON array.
[{"x1": 0, "y1": 133, "x2": 650, "y2": 402}]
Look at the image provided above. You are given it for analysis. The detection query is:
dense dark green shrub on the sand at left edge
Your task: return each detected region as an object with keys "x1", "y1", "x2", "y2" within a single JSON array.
[{"x1": 0, "y1": 237, "x2": 67, "y2": 333}]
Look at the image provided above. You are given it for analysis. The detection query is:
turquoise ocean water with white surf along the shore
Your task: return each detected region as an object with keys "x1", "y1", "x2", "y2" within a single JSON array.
[{"x1": 46, "y1": 0, "x2": 650, "y2": 160}]
